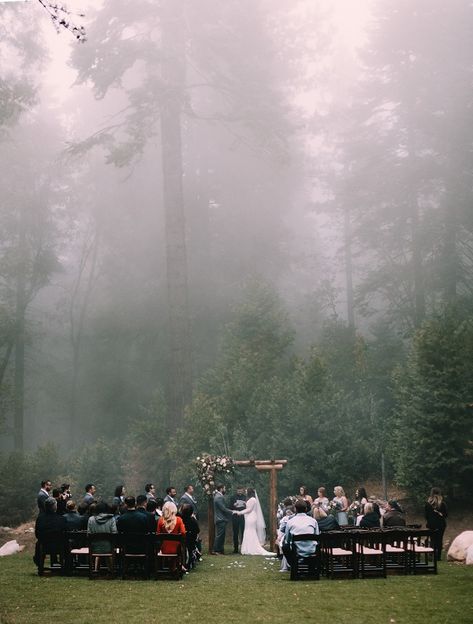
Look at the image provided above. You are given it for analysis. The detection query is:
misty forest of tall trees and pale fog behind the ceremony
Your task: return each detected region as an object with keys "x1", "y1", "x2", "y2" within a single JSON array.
[{"x1": 0, "y1": 0, "x2": 473, "y2": 524}]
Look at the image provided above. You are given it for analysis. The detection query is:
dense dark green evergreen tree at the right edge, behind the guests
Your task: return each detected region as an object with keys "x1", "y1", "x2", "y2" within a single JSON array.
[{"x1": 392, "y1": 306, "x2": 473, "y2": 498}]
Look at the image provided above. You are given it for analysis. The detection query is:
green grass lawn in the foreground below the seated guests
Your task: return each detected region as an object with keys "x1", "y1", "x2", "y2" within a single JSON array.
[{"x1": 0, "y1": 554, "x2": 473, "y2": 624}]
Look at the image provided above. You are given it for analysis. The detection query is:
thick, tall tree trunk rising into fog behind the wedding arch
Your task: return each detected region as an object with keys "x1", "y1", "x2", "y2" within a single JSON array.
[{"x1": 161, "y1": 0, "x2": 192, "y2": 432}]
